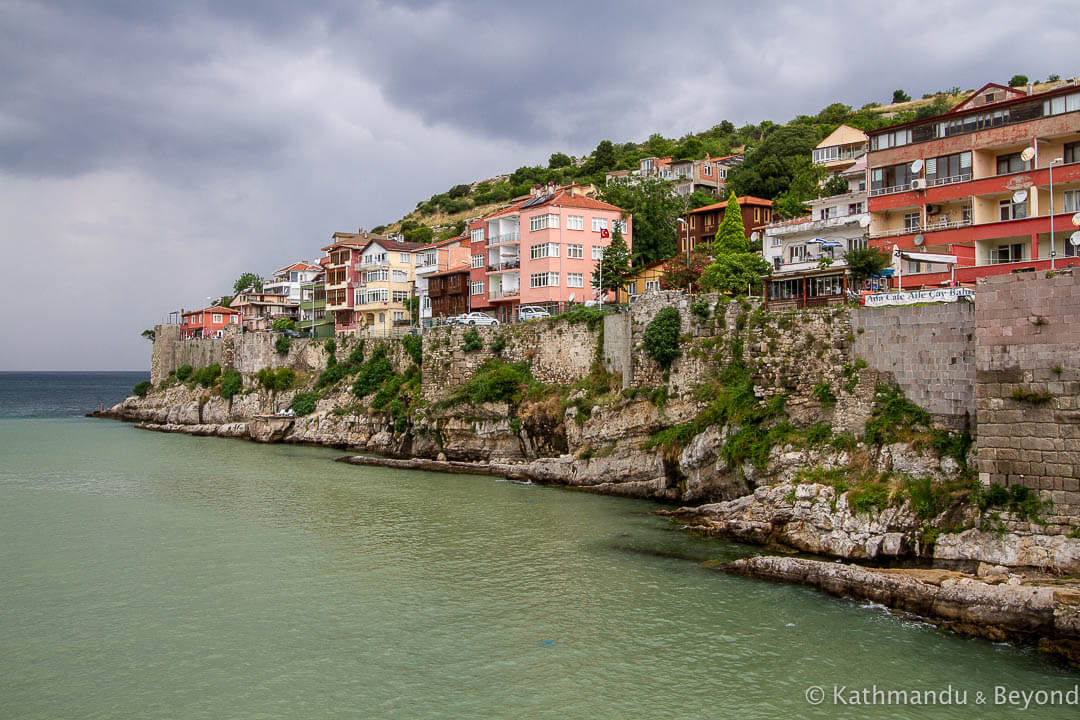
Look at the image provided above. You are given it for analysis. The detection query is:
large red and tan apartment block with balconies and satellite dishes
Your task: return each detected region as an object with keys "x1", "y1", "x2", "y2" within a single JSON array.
[{"x1": 867, "y1": 83, "x2": 1080, "y2": 288}]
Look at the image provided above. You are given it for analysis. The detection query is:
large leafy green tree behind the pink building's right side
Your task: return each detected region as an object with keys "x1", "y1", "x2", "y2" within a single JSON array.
[{"x1": 600, "y1": 178, "x2": 684, "y2": 266}]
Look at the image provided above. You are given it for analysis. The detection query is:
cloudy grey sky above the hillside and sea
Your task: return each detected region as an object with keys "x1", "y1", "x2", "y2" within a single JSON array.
[{"x1": 0, "y1": 0, "x2": 1080, "y2": 370}]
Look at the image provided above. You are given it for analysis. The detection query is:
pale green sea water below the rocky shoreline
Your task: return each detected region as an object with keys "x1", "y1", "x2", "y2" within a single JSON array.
[{"x1": 0, "y1": 377, "x2": 1080, "y2": 718}]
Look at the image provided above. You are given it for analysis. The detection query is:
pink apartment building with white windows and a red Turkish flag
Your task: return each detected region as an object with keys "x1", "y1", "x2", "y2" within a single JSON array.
[{"x1": 483, "y1": 186, "x2": 633, "y2": 322}]
